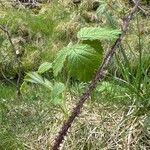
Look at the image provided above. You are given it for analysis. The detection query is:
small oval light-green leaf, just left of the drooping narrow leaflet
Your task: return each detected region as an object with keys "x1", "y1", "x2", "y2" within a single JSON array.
[{"x1": 38, "y1": 62, "x2": 52, "y2": 74}]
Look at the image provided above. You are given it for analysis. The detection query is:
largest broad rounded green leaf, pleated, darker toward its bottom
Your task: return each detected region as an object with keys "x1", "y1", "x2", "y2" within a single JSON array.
[{"x1": 67, "y1": 44, "x2": 102, "y2": 81}]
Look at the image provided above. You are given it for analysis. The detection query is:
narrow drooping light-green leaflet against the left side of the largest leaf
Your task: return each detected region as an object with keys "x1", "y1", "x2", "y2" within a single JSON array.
[{"x1": 53, "y1": 47, "x2": 68, "y2": 77}]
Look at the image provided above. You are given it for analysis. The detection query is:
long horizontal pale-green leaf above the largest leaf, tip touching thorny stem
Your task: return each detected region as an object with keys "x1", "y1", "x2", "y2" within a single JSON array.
[{"x1": 77, "y1": 27, "x2": 120, "y2": 40}]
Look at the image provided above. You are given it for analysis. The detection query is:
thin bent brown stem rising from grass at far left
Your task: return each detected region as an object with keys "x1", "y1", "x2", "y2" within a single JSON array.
[{"x1": 0, "y1": 25, "x2": 22, "y2": 97}]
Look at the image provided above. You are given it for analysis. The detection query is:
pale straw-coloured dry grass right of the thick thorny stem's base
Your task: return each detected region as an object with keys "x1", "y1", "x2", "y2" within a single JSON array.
[{"x1": 62, "y1": 104, "x2": 150, "y2": 150}]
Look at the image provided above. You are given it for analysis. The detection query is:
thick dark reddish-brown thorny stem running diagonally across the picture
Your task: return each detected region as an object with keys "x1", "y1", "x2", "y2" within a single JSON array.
[{"x1": 51, "y1": 0, "x2": 139, "y2": 150}]
